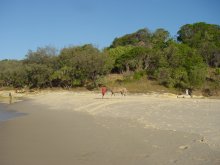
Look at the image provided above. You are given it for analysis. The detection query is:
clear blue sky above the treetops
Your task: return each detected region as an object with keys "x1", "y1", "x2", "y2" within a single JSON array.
[{"x1": 0, "y1": 0, "x2": 220, "y2": 60}]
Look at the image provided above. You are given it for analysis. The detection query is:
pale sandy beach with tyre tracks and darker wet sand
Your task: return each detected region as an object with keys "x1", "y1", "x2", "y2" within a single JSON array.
[{"x1": 0, "y1": 91, "x2": 220, "y2": 165}]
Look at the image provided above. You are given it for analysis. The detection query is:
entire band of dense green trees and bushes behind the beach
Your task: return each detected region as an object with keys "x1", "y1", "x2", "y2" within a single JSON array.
[{"x1": 0, "y1": 22, "x2": 220, "y2": 93}]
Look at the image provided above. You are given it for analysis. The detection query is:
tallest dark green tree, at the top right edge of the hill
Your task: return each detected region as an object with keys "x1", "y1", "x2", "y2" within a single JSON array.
[{"x1": 177, "y1": 22, "x2": 220, "y2": 67}]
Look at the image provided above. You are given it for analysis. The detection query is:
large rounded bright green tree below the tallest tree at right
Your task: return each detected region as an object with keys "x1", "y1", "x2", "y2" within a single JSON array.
[{"x1": 154, "y1": 42, "x2": 207, "y2": 89}]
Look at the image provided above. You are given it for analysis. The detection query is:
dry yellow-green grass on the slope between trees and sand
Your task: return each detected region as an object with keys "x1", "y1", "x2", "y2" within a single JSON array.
[{"x1": 100, "y1": 74, "x2": 220, "y2": 98}]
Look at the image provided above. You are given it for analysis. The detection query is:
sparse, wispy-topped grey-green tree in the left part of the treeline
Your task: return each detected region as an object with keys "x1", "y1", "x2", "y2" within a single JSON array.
[{"x1": 23, "y1": 46, "x2": 58, "y2": 88}]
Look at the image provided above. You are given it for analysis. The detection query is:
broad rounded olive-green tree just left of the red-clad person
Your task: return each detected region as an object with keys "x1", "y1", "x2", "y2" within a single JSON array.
[{"x1": 59, "y1": 44, "x2": 112, "y2": 86}]
